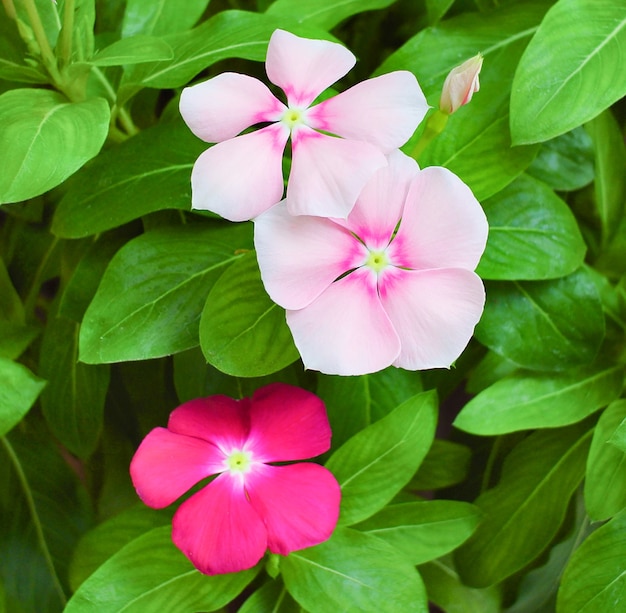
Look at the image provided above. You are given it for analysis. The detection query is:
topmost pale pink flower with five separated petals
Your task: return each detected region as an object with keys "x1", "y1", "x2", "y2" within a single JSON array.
[{"x1": 180, "y1": 30, "x2": 428, "y2": 221}]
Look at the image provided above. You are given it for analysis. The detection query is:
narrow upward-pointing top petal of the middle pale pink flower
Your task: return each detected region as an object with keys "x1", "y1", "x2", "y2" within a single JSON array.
[{"x1": 338, "y1": 151, "x2": 419, "y2": 250}]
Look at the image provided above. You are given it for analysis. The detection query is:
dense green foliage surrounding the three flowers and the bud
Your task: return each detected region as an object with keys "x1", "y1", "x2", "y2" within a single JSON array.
[{"x1": 0, "y1": 0, "x2": 626, "y2": 613}]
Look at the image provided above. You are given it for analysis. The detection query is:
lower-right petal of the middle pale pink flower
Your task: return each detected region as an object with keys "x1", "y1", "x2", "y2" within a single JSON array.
[{"x1": 379, "y1": 267, "x2": 485, "y2": 370}]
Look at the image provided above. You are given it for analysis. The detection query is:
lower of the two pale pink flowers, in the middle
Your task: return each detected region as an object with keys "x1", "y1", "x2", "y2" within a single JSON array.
[{"x1": 255, "y1": 151, "x2": 488, "y2": 375}]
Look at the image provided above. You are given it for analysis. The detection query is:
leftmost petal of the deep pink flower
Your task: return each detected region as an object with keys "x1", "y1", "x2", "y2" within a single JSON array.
[{"x1": 130, "y1": 428, "x2": 224, "y2": 509}]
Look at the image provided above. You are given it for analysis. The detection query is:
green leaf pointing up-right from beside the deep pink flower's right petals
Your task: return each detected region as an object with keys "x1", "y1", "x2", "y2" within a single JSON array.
[{"x1": 326, "y1": 392, "x2": 437, "y2": 525}]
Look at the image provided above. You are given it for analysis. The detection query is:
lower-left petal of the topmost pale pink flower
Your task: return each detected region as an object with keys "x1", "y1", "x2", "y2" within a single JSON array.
[{"x1": 191, "y1": 124, "x2": 289, "y2": 221}]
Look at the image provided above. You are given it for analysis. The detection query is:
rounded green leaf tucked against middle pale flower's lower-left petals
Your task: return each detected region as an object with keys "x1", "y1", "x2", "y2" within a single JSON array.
[{"x1": 200, "y1": 252, "x2": 299, "y2": 377}]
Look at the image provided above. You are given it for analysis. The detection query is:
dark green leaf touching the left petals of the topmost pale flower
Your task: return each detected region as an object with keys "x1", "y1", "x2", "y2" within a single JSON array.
[{"x1": 52, "y1": 122, "x2": 206, "y2": 238}]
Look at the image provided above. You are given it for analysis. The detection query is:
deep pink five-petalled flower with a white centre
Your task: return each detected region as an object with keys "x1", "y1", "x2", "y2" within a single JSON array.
[{"x1": 130, "y1": 383, "x2": 341, "y2": 575}]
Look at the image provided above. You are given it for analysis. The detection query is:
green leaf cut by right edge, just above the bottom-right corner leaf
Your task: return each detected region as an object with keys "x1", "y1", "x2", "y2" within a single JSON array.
[{"x1": 585, "y1": 399, "x2": 626, "y2": 521}]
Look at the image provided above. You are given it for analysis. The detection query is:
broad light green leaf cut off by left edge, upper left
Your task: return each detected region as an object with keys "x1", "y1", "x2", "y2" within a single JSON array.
[{"x1": 0, "y1": 89, "x2": 110, "y2": 204}]
